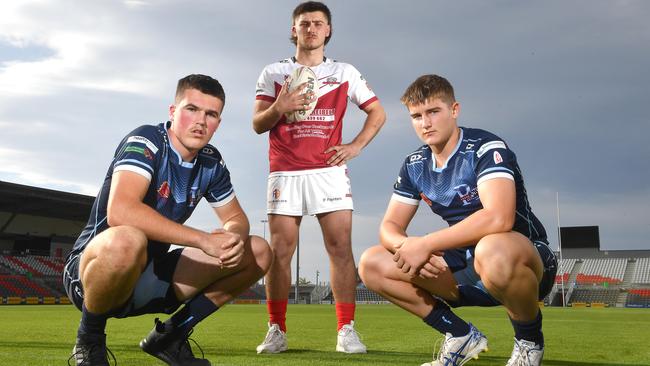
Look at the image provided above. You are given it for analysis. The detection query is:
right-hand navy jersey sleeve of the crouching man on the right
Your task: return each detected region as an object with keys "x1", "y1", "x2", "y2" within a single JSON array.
[{"x1": 475, "y1": 139, "x2": 517, "y2": 186}]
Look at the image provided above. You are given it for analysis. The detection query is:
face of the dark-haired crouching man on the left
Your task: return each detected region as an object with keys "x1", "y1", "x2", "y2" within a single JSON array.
[{"x1": 169, "y1": 89, "x2": 223, "y2": 160}]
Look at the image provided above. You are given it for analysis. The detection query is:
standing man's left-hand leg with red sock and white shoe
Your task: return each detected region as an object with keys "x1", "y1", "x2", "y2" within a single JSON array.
[{"x1": 257, "y1": 215, "x2": 302, "y2": 353}]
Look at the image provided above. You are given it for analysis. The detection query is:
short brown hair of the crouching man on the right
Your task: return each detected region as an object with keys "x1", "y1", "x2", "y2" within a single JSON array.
[{"x1": 400, "y1": 74, "x2": 456, "y2": 107}]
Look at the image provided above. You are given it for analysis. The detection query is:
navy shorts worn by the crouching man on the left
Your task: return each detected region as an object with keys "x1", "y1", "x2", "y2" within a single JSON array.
[{"x1": 63, "y1": 248, "x2": 183, "y2": 318}]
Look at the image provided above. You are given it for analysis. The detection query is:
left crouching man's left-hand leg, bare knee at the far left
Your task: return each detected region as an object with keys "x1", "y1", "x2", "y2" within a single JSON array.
[{"x1": 73, "y1": 226, "x2": 147, "y2": 365}]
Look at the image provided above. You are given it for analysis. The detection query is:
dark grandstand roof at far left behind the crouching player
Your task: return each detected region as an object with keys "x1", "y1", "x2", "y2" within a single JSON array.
[{"x1": 0, "y1": 181, "x2": 95, "y2": 222}]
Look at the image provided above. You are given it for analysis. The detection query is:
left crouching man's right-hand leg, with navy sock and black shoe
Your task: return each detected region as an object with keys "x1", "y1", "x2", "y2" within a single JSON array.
[{"x1": 140, "y1": 236, "x2": 273, "y2": 365}]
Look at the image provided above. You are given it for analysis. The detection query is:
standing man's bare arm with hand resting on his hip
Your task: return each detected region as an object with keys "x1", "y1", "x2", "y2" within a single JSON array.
[{"x1": 325, "y1": 100, "x2": 386, "y2": 166}]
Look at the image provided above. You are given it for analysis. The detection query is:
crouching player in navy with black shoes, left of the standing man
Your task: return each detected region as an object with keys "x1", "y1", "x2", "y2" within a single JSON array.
[{"x1": 63, "y1": 75, "x2": 272, "y2": 365}]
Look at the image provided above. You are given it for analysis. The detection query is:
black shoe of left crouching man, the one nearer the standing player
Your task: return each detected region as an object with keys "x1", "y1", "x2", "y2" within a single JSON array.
[{"x1": 140, "y1": 318, "x2": 211, "y2": 366}]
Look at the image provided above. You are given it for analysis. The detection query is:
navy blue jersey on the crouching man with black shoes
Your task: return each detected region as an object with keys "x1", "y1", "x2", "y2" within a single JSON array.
[{"x1": 70, "y1": 122, "x2": 235, "y2": 256}]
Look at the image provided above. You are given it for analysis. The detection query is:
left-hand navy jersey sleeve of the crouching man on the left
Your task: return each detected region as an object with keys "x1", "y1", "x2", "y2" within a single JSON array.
[{"x1": 113, "y1": 126, "x2": 164, "y2": 181}]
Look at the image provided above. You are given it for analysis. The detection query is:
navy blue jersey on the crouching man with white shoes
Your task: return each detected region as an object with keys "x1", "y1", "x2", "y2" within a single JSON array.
[{"x1": 393, "y1": 127, "x2": 546, "y2": 241}]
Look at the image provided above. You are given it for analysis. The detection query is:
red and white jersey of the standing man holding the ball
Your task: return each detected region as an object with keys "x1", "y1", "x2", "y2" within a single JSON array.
[{"x1": 255, "y1": 57, "x2": 377, "y2": 172}]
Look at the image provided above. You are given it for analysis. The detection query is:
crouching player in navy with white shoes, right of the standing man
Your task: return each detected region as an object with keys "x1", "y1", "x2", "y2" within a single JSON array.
[{"x1": 359, "y1": 75, "x2": 557, "y2": 366}]
